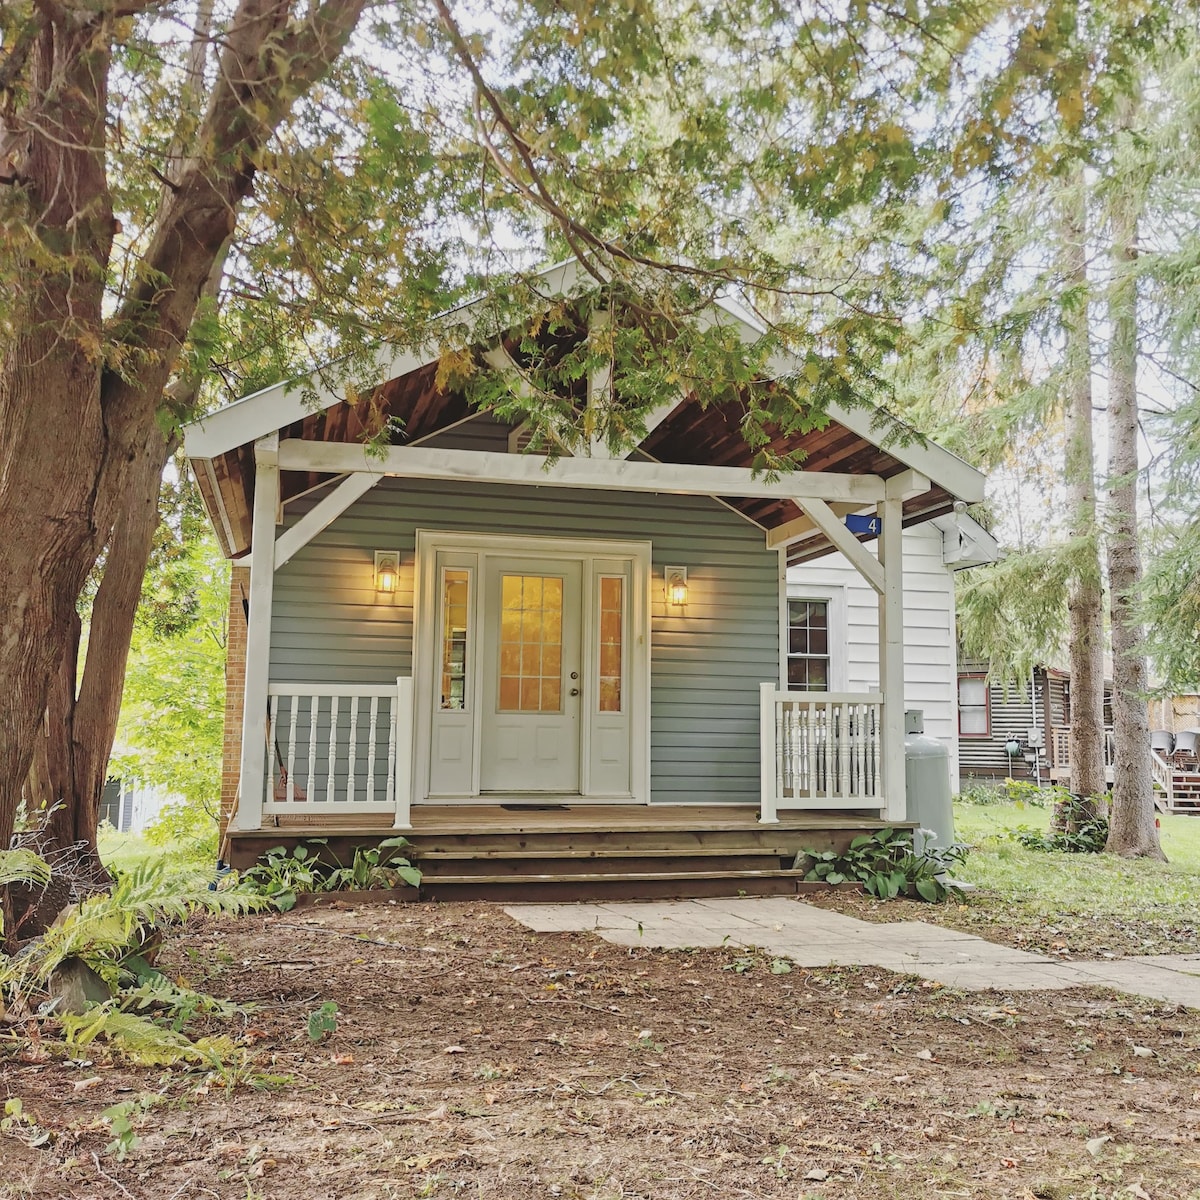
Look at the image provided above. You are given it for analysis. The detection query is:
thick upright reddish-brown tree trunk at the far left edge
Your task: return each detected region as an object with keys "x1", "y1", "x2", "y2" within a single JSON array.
[{"x1": 0, "y1": 11, "x2": 114, "y2": 845}]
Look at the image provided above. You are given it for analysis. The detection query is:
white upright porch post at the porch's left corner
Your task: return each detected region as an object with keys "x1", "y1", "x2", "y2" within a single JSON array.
[{"x1": 233, "y1": 433, "x2": 280, "y2": 829}]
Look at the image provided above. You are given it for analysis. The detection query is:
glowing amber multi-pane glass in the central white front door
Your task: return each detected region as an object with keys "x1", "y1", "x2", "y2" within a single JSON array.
[{"x1": 498, "y1": 575, "x2": 563, "y2": 713}]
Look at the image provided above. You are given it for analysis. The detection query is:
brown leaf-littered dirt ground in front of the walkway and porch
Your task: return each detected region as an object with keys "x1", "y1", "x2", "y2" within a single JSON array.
[{"x1": 0, "y1": 904, "x2": 1200, "y2": 1200}]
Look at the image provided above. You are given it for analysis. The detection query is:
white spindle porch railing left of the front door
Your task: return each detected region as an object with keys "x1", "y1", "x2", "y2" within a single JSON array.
[{"x1": 263, "y1": 677, "x2": 413, "y2": 828}]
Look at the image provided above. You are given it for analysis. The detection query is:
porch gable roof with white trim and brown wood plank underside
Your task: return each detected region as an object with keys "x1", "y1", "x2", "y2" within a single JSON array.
[{"x1": 185, "y1": 262, "x2": 984, "y2": 562}]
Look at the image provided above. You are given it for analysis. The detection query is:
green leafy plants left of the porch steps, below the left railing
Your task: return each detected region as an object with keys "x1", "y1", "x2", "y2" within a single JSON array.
[{"x1": 242, "y1": 836, "x2": 421, "y2": 912}]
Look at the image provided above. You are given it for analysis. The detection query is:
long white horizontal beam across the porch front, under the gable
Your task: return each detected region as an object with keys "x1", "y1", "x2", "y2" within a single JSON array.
[{"x1": 278, "y1": 438, "x2": 884, "y2": 504}]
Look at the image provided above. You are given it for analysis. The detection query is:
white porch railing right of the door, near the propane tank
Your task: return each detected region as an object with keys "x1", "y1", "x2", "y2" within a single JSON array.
[{"x1": 760, "y1": 683, "x2": 887, "y2": 822}]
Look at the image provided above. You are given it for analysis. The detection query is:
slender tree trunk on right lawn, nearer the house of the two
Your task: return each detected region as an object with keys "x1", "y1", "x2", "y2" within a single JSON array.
[{"x1": 1062, "y1": 170, "x2": 1108, "y2": 824}]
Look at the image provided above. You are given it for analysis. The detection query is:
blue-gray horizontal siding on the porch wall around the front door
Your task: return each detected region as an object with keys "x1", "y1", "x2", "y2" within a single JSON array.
[{"x1": 271, "y1": 463, "x2": 779, "y2": 803}]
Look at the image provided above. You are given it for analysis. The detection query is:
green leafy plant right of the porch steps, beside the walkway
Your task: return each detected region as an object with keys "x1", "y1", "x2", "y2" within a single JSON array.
[{"x1": 803, "y1": 828, "x2": 967, "y2": 904}]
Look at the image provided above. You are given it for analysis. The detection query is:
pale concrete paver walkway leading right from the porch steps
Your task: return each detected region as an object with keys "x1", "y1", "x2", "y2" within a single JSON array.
[{"x1": 504, "y1": 896, "x2": 1200, "y2": 1008}]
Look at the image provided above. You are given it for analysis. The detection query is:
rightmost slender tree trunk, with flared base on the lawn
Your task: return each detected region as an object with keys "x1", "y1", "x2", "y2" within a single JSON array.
[{"x1": 1105, "y1": 98, "x2": 1165, "y2": 858}]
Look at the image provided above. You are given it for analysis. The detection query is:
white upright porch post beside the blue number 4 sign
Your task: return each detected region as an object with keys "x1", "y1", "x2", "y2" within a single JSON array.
[{"x1": 876, "y1": 496, "x2": 908, "y2": 821}]
